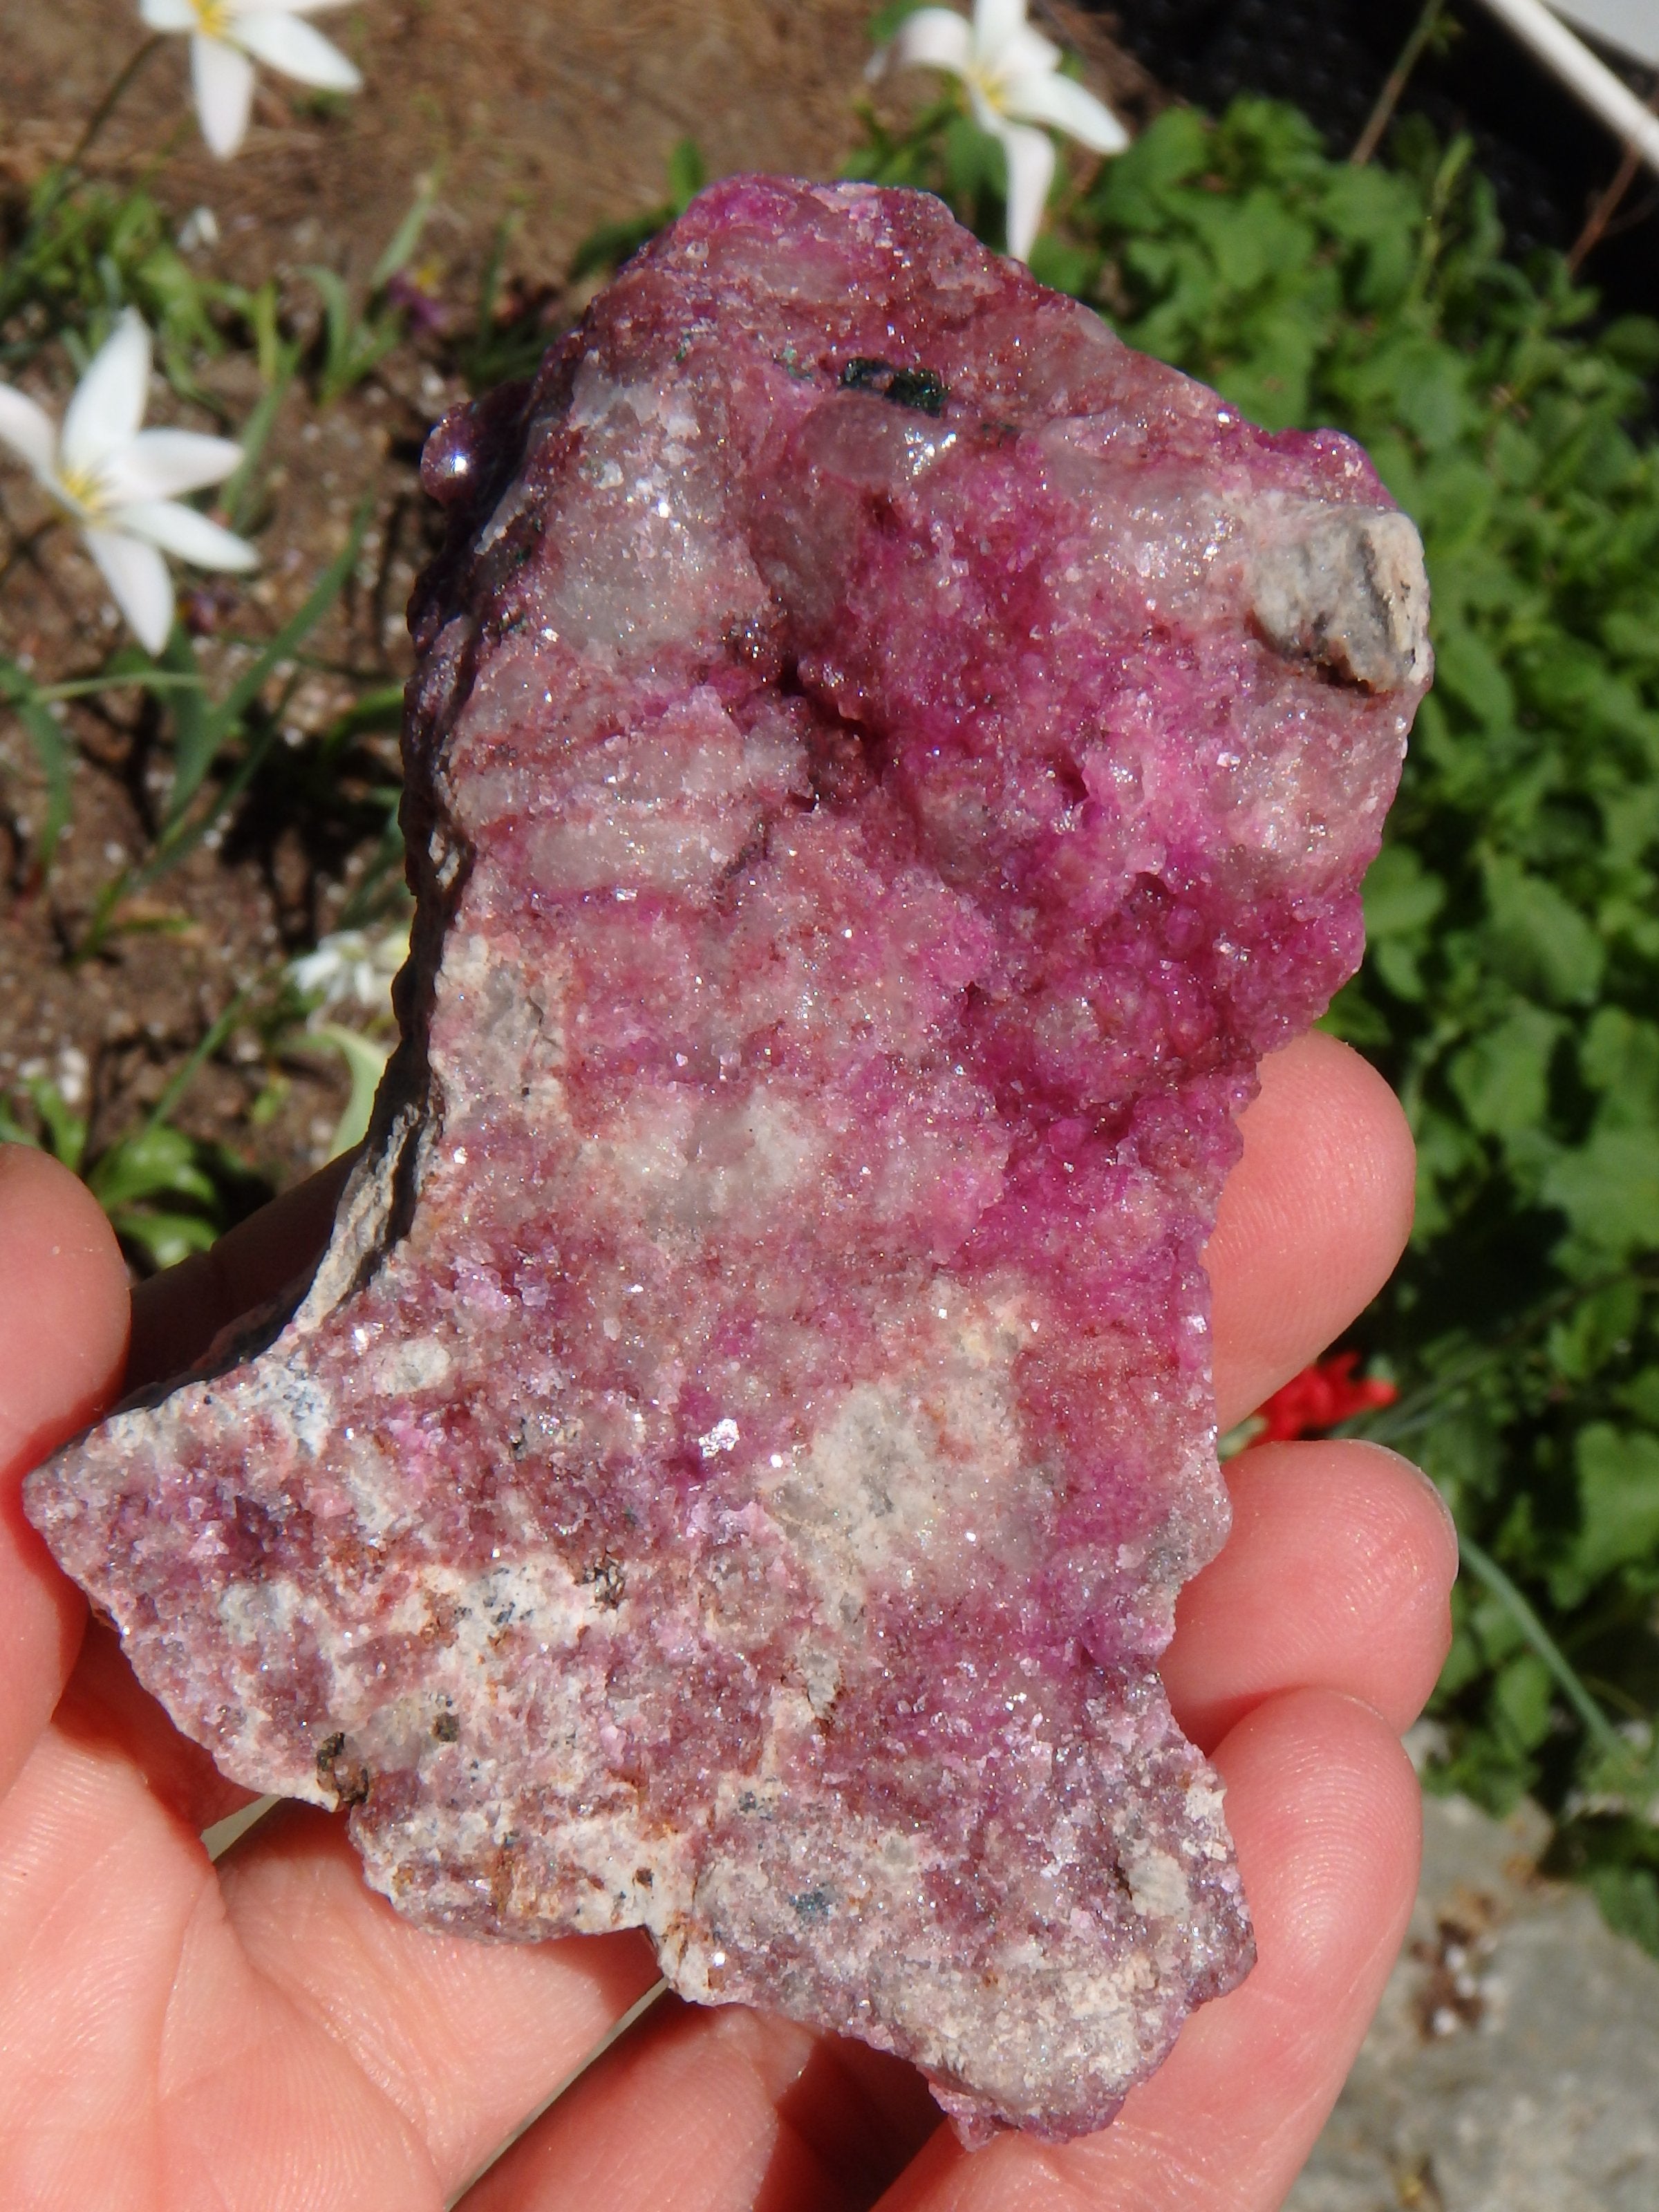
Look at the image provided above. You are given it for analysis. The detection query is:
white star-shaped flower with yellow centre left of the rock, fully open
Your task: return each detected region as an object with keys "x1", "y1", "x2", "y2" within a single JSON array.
[{"x1": 0, "y1": 308, "x2": 259, "y2": 653}]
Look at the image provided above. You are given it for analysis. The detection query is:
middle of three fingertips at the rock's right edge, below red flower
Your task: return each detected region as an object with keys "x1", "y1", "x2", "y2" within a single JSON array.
[{"x1": 1161, "y1": 1442, "x2": 1458, "y2": 1750}]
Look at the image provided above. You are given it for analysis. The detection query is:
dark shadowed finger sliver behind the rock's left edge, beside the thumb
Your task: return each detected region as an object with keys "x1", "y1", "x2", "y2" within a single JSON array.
[{"x1": 129, "y1": 1152, "x2": 356, "y2": 1389}]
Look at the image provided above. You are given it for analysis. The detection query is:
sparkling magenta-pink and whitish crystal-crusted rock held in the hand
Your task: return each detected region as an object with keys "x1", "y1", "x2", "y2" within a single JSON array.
[{"x1": 29, "y1": 179, "x2": 1429, "y2": 2137}]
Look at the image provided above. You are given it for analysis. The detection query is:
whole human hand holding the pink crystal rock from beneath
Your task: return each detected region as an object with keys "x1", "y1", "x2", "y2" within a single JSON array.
[{"x1": 0, "y1": 1038, "x2": 1456, "y2": 2212}]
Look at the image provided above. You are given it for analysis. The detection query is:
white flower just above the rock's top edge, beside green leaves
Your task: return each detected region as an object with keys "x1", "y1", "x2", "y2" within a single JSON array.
[{"x1": 872, "y1": 0, "x2": 1128, "y2": 261}]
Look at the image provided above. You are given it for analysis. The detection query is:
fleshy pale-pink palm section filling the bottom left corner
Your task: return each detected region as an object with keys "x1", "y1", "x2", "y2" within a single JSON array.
[{"x1": 0, "y1": 1723, "x2": 442, "y2": 2212}]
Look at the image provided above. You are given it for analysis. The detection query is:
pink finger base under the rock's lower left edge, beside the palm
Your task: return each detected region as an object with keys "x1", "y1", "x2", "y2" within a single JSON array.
[{"x1": 219, "y1": 1807, "x2": 657, "y2": 2192}]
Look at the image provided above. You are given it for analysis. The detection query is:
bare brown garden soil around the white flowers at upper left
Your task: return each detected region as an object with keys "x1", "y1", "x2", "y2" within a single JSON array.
[{"x1": 0, "y1": 0, "x2": 911, "y2": 1221}]
